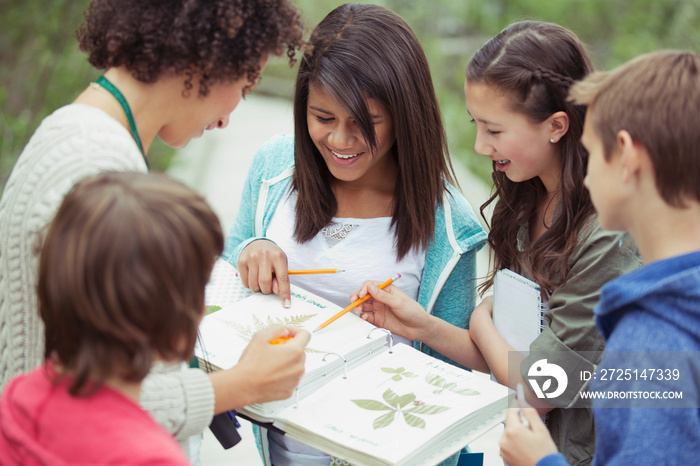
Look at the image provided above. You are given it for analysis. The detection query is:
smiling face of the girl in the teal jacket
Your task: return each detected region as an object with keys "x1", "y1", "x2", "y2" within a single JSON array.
[{"x1": 306, "y1": 85, "x2": 397, "y2": 186}]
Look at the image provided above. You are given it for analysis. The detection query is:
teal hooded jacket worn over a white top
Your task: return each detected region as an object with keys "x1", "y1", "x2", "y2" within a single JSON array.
[{"x1": 222, "y1": 135, "x2": 486, "y2": 365}]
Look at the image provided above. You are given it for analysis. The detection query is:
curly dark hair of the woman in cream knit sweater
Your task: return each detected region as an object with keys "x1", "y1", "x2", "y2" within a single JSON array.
[{"x1": 75, "y1": 0, "x2": 303, "y2": 97}]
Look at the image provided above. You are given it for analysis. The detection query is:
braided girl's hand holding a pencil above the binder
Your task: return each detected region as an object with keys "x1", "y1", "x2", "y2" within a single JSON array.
[{"x1": 350, "y1": 281, "x2": 431, "y2": 340}]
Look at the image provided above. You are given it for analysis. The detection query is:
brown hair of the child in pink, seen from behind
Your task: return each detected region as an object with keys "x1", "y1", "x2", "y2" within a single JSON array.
[{"x1": 38, "y1": 173, "x2": 223, "y2": 394}]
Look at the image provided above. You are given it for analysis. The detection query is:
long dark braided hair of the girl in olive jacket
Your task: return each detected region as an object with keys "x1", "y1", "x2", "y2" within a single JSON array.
[{"x1": 466, "y1": 21, "x2": 594, "y2": 293}]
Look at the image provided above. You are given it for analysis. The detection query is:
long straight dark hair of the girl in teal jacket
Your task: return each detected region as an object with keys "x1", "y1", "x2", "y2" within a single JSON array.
[{"x1": 292, "y1": 4, "x2": 454, "y2": 259}]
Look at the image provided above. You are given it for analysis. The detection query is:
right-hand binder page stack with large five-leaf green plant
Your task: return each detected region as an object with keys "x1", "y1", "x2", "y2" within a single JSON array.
[{"x1": 274, "y1": 343, "x2": 510, "y2": 465}]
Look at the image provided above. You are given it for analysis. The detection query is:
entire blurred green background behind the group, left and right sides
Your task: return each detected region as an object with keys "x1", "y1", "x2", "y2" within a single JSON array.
[{"x1": 0, "y1": 0, "x2": 700, "y2": 190}]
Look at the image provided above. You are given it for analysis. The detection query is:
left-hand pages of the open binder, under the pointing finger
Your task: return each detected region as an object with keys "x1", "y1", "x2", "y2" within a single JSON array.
[{"x1": 195, "y1": 260, "x2": 388, "y2": 422}]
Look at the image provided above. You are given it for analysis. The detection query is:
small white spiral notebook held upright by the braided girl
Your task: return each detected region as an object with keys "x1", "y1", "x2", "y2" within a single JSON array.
[{"x1": 493, "y1": 269, "x2": 549, "y2": 354}]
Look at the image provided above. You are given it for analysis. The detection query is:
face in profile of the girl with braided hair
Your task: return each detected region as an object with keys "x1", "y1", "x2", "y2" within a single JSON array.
[{"x1": 464, "y1": 81, "x2": 561, "y2": 191}]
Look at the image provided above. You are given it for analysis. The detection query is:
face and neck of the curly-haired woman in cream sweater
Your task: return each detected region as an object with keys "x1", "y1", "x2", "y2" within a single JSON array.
[{"x1": 158, "y1": 57, "x2": 267, "y2": 148}]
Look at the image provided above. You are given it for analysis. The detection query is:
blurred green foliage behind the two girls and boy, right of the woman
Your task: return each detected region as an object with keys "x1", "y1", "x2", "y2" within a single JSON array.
[{"x1": 262, "y1": 0, "x2": 700, "y2": 185}]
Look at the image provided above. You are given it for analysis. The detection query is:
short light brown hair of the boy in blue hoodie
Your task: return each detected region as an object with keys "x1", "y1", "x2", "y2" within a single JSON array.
[{"x1": 571, "y1": 50, "x2": 700, "y2": 207}]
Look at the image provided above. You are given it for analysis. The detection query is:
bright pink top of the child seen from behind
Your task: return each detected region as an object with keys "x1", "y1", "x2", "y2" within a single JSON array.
[{"x1": 0, "y1": 366, "x2": 189, "y2": 465}]
